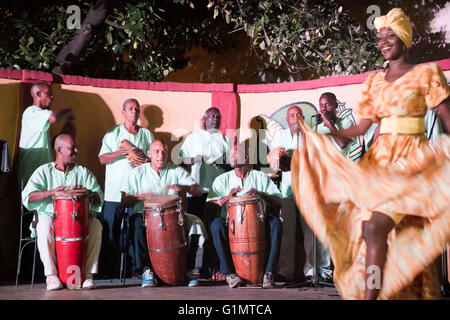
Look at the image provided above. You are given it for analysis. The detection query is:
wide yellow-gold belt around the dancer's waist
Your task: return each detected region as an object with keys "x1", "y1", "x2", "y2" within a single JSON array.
[{"x1": 380, "y1": 117, "x2": 425, "y2": 134}]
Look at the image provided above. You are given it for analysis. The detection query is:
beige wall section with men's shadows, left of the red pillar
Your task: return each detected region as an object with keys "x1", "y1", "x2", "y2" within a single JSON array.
[{"x1": 51, "y1": 84, "x2": 211, "y2": 188}]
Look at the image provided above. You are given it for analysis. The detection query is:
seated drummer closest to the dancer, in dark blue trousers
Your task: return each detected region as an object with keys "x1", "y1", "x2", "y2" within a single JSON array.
[{"x1": 208, "y1": 144, "x2": 282, "y2": 288}]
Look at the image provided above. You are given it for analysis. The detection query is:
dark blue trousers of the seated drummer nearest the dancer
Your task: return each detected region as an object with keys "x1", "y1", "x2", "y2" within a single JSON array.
[{"x1": 211, "y1": 216, "x2": 282, "y2": 274}]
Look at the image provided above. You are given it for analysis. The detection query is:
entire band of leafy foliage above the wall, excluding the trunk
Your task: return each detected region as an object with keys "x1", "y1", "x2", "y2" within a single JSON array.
[{"x1": 0, "y1": 0, "x2": 449, "y2": 81}]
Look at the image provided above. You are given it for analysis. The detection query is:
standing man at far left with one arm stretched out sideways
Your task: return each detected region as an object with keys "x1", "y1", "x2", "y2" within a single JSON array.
[{"x1": 18, "y1": 82, "x2": 73, "y2": 186}]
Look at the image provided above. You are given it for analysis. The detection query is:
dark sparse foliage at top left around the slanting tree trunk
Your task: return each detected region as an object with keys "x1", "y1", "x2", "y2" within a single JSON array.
[{"x1": 0, "y1": 0, "x2": 221, "y2": 81}]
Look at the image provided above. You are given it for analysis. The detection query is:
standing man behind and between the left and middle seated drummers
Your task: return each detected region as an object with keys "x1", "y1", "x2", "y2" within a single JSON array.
[{"x1": 98, "y1": 98, "x2": 154, "y2": 276}]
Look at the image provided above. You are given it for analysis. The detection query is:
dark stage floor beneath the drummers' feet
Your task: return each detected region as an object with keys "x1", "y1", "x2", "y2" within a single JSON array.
[{"x1": 0, "y1": 278, "x2": 341, "y2": 300}]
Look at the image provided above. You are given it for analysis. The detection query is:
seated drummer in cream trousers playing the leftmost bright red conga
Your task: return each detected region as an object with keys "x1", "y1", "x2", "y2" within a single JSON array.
[{"x1": 22, "y1": 134, "x2": 103, "y2": 290}]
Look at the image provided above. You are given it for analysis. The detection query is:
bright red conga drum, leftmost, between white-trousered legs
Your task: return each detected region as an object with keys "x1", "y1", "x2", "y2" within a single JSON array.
[{"x1": 53, "y1": 190, "x2": 89, "y2": 289}]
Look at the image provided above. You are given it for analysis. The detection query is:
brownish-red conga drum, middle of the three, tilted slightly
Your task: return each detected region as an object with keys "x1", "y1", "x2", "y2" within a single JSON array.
[{"x1": 144, "y1": 196, "x2": 188, "y2": 285}]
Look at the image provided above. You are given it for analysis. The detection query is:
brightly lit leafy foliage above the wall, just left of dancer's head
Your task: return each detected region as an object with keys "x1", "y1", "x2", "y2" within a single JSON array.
[{"x1": 208, "y1": 0, "x2": 382, "y2": 76}]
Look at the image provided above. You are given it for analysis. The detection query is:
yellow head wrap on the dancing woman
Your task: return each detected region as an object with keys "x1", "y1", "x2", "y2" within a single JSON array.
[{"x1": 373, "y1": 8, "x2": 412, "y2": 48}]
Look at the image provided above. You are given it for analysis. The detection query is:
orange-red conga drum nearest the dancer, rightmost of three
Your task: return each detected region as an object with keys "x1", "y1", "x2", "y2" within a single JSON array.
[{"x1": 227, "y1": 196, "x2": 266, "y2": 285}]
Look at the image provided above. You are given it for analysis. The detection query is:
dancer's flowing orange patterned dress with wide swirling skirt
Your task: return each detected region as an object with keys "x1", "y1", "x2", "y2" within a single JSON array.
[{"x1": 291, "y1": 64, "x2": 450, "y2": 299}]
